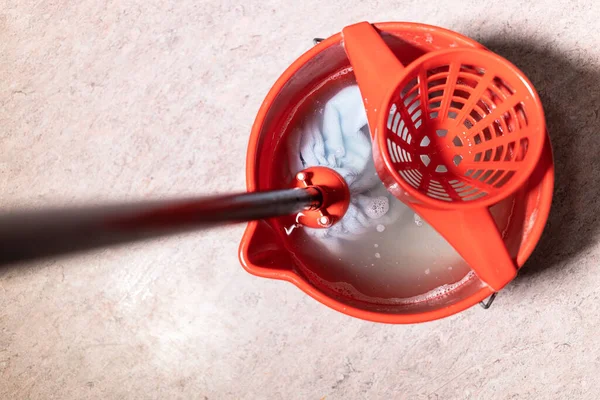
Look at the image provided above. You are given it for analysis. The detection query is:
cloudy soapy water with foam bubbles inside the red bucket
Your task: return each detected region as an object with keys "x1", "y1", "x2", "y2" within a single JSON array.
[{"x1": 278, "y1": 75, "x2": 513, "y2": 305}]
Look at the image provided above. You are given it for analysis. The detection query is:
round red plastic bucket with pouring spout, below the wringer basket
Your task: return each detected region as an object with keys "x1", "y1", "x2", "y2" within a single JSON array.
[{"x1": 240, "y1": 22, "x2": 554, "y2": 323}]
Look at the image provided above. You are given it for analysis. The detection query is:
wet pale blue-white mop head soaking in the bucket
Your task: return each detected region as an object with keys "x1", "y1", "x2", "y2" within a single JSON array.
[{"x1": 288, "y1": 85, "x2": 398, "y2": 240}]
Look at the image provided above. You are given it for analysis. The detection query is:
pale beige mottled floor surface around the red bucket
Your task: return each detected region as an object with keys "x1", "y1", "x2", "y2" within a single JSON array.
[{"x1": 0, "y1": 0, "x2": 600, "y2": 400}]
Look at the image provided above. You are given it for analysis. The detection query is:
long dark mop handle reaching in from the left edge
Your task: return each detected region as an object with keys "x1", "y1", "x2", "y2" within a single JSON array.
[{"x1": 0, "y1": 187, "x2": 323, "y2": 265}]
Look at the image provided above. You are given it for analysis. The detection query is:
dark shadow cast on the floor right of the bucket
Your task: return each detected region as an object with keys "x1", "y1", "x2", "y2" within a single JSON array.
[{"x1": 478, "y1": 35, "x2": 600, "y2": 277}]
